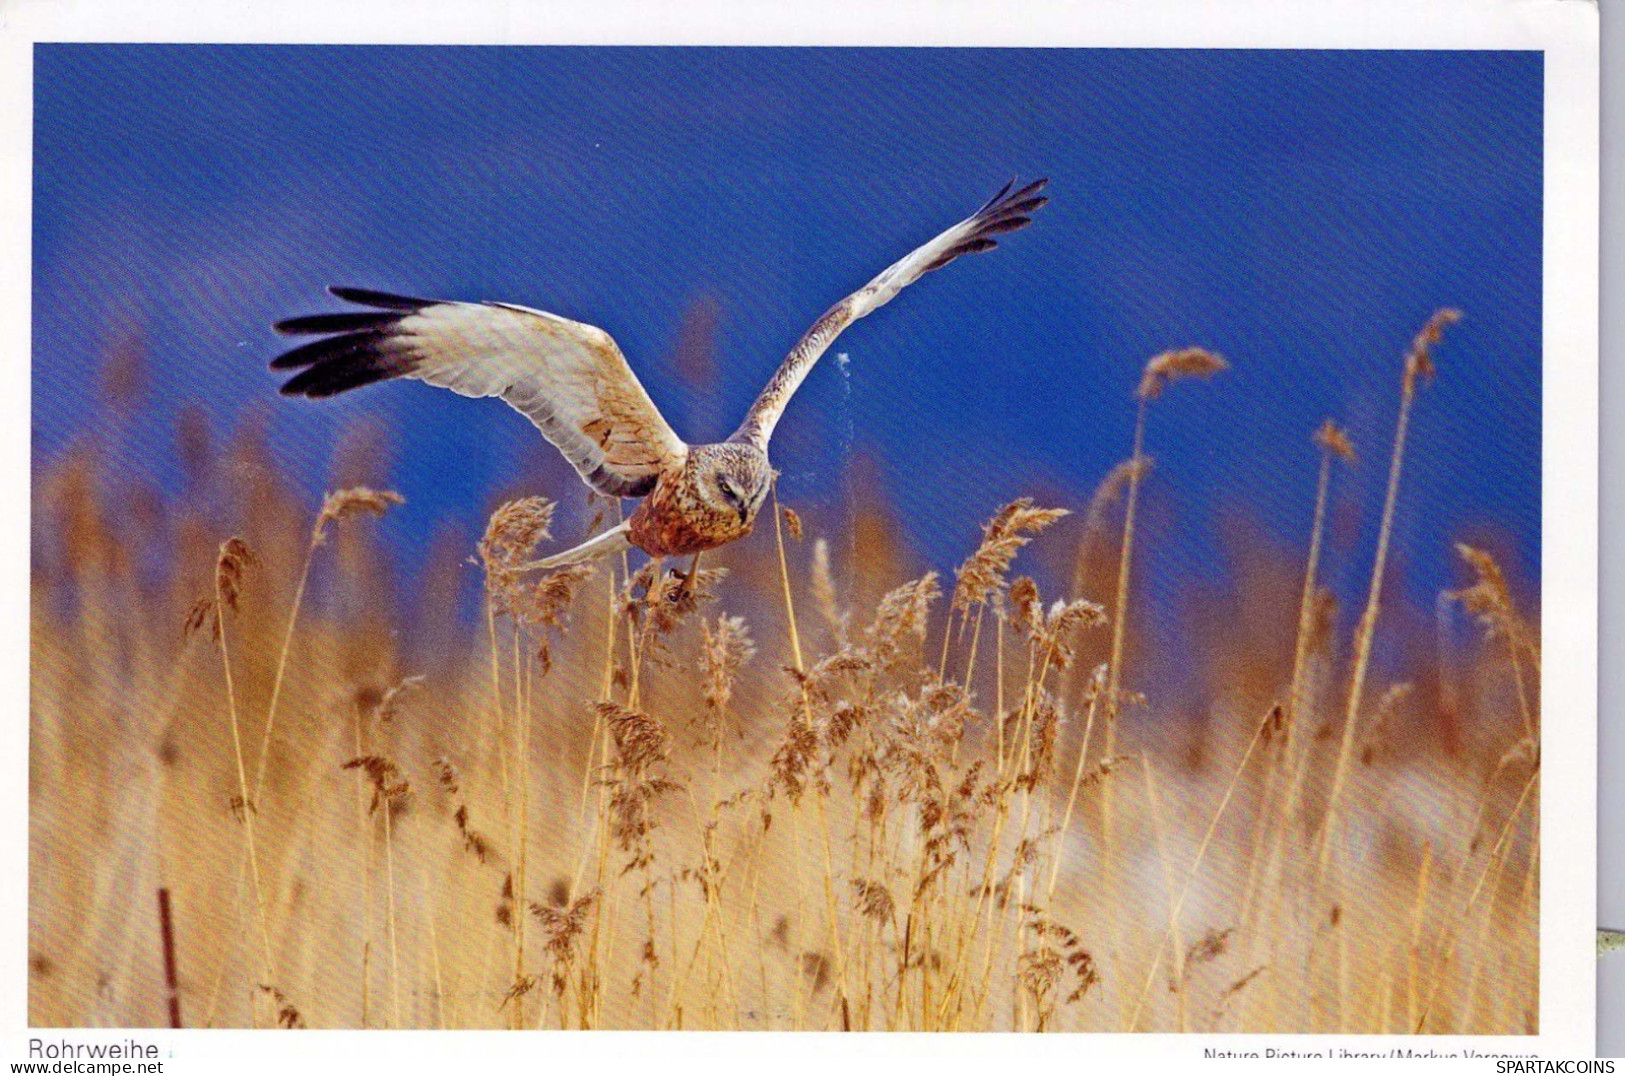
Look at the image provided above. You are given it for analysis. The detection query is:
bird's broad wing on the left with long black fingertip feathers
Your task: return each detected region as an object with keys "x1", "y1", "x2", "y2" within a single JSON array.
[{"x1": 271, "y1": 288, "x2": 687, "y2": 497}]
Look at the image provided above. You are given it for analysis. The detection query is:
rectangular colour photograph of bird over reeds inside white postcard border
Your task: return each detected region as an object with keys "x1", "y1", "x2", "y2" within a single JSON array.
[{"x1": 31, "y1": 44, "x2": 1544, "y2": 1035}]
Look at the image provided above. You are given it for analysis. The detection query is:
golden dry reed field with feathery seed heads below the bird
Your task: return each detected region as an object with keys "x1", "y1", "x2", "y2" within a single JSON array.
[{"x1": 29, "y1": 312, "x2": 1539, "y2": 1034}]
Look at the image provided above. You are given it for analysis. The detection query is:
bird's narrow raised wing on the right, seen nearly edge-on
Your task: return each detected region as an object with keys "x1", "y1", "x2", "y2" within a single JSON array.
[{"x1": 731, "y1": 179, "x2": 1050, "y2": 450}]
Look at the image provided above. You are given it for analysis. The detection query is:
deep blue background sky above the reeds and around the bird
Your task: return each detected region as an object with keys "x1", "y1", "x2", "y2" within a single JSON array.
[{"x1": 33, "y1": 46, "x2": 1542, "y2": 614}]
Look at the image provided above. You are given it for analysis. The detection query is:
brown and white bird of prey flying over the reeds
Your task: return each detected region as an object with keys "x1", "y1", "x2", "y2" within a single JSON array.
[{"x1": 271, "y1": 179, "x2": 1047, "y2": 575}]
